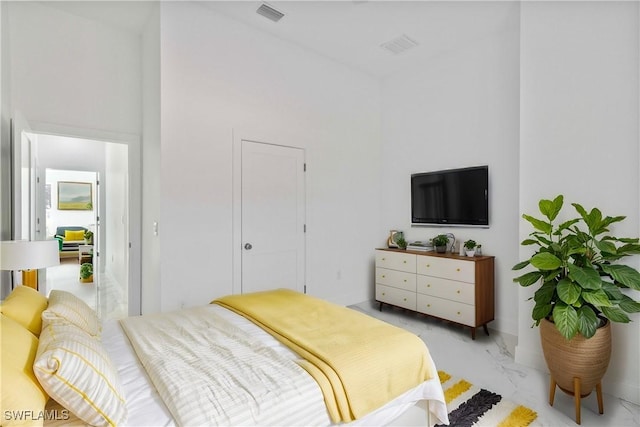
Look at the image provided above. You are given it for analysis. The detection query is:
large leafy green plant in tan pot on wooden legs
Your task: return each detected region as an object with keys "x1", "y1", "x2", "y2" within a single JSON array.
[{"x1": 513, "y1": 195, "x2": 640, "y2": 424}]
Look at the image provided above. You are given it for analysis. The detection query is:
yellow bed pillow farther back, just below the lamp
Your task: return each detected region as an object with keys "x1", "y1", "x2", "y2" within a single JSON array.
[{"x1": 0, "y1": 286, "x2": 47, "y2": 337}]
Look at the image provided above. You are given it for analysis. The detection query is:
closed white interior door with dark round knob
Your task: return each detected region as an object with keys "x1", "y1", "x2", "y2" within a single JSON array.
[{"x1": 241, "y1": 140, "x2": 305, "y2": 293}]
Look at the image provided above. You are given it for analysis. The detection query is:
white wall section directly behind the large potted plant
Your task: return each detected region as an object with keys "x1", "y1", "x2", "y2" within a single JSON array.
[{"x1": 516, "y1": 2, "x2": 640, "y2": 403}]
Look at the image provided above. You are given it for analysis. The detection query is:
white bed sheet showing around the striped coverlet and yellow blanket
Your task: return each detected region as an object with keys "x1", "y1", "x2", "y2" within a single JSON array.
[{"x1": 47, "y1": 305, "x2": 447, "y2": 427}]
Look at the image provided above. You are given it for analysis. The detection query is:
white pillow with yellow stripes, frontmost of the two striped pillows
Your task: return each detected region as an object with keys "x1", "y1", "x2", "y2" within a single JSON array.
[{"x1": 33, "y1": 322, "x2": 127, "y2": 426}]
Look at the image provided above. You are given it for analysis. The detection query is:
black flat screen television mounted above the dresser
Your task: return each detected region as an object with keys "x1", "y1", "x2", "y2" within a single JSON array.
[{"x1": 411, "y1": 166, "x2": 489, "y2": 227}]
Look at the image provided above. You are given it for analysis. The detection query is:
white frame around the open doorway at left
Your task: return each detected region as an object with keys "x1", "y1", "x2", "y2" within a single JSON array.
[{"x1": 28, "y1": 122, "x2": 142, "y2": 316}]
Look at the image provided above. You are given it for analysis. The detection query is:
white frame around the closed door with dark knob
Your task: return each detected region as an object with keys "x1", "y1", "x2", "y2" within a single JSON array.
[{"x1": 231, "y1": 130, "x2": 307, "y2": 294}]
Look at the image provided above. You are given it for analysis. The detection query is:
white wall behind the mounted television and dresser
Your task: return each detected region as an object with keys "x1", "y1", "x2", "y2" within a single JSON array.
[{"x1": 376, "y1": 2, "x2": 519, "y2": 335}]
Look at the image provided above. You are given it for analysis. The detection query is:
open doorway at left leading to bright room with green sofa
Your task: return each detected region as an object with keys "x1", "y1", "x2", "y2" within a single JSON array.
[{"x1": 16, "y1": 131, "x2": 131, "y2": 319}]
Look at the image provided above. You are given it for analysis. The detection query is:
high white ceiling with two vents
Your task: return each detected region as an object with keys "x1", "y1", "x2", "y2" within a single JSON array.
[{"x1": 41, "y1": 0, "x2": 519, "y2": 77}]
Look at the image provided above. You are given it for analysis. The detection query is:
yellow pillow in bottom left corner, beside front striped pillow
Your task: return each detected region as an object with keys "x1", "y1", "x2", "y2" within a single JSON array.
[{"x1": 0, "y1": 314, "x2": 49, "y2": 426}]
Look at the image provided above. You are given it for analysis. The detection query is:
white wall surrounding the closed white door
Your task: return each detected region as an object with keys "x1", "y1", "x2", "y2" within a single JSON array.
[{"x1": 160, "y1": 2, "x2": 380, "y2": 310}]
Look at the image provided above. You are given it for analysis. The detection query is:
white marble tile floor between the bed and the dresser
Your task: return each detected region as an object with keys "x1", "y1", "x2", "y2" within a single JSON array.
[{"x1": 350, "y1": 301, "x2": 640, "y2": 427}]
